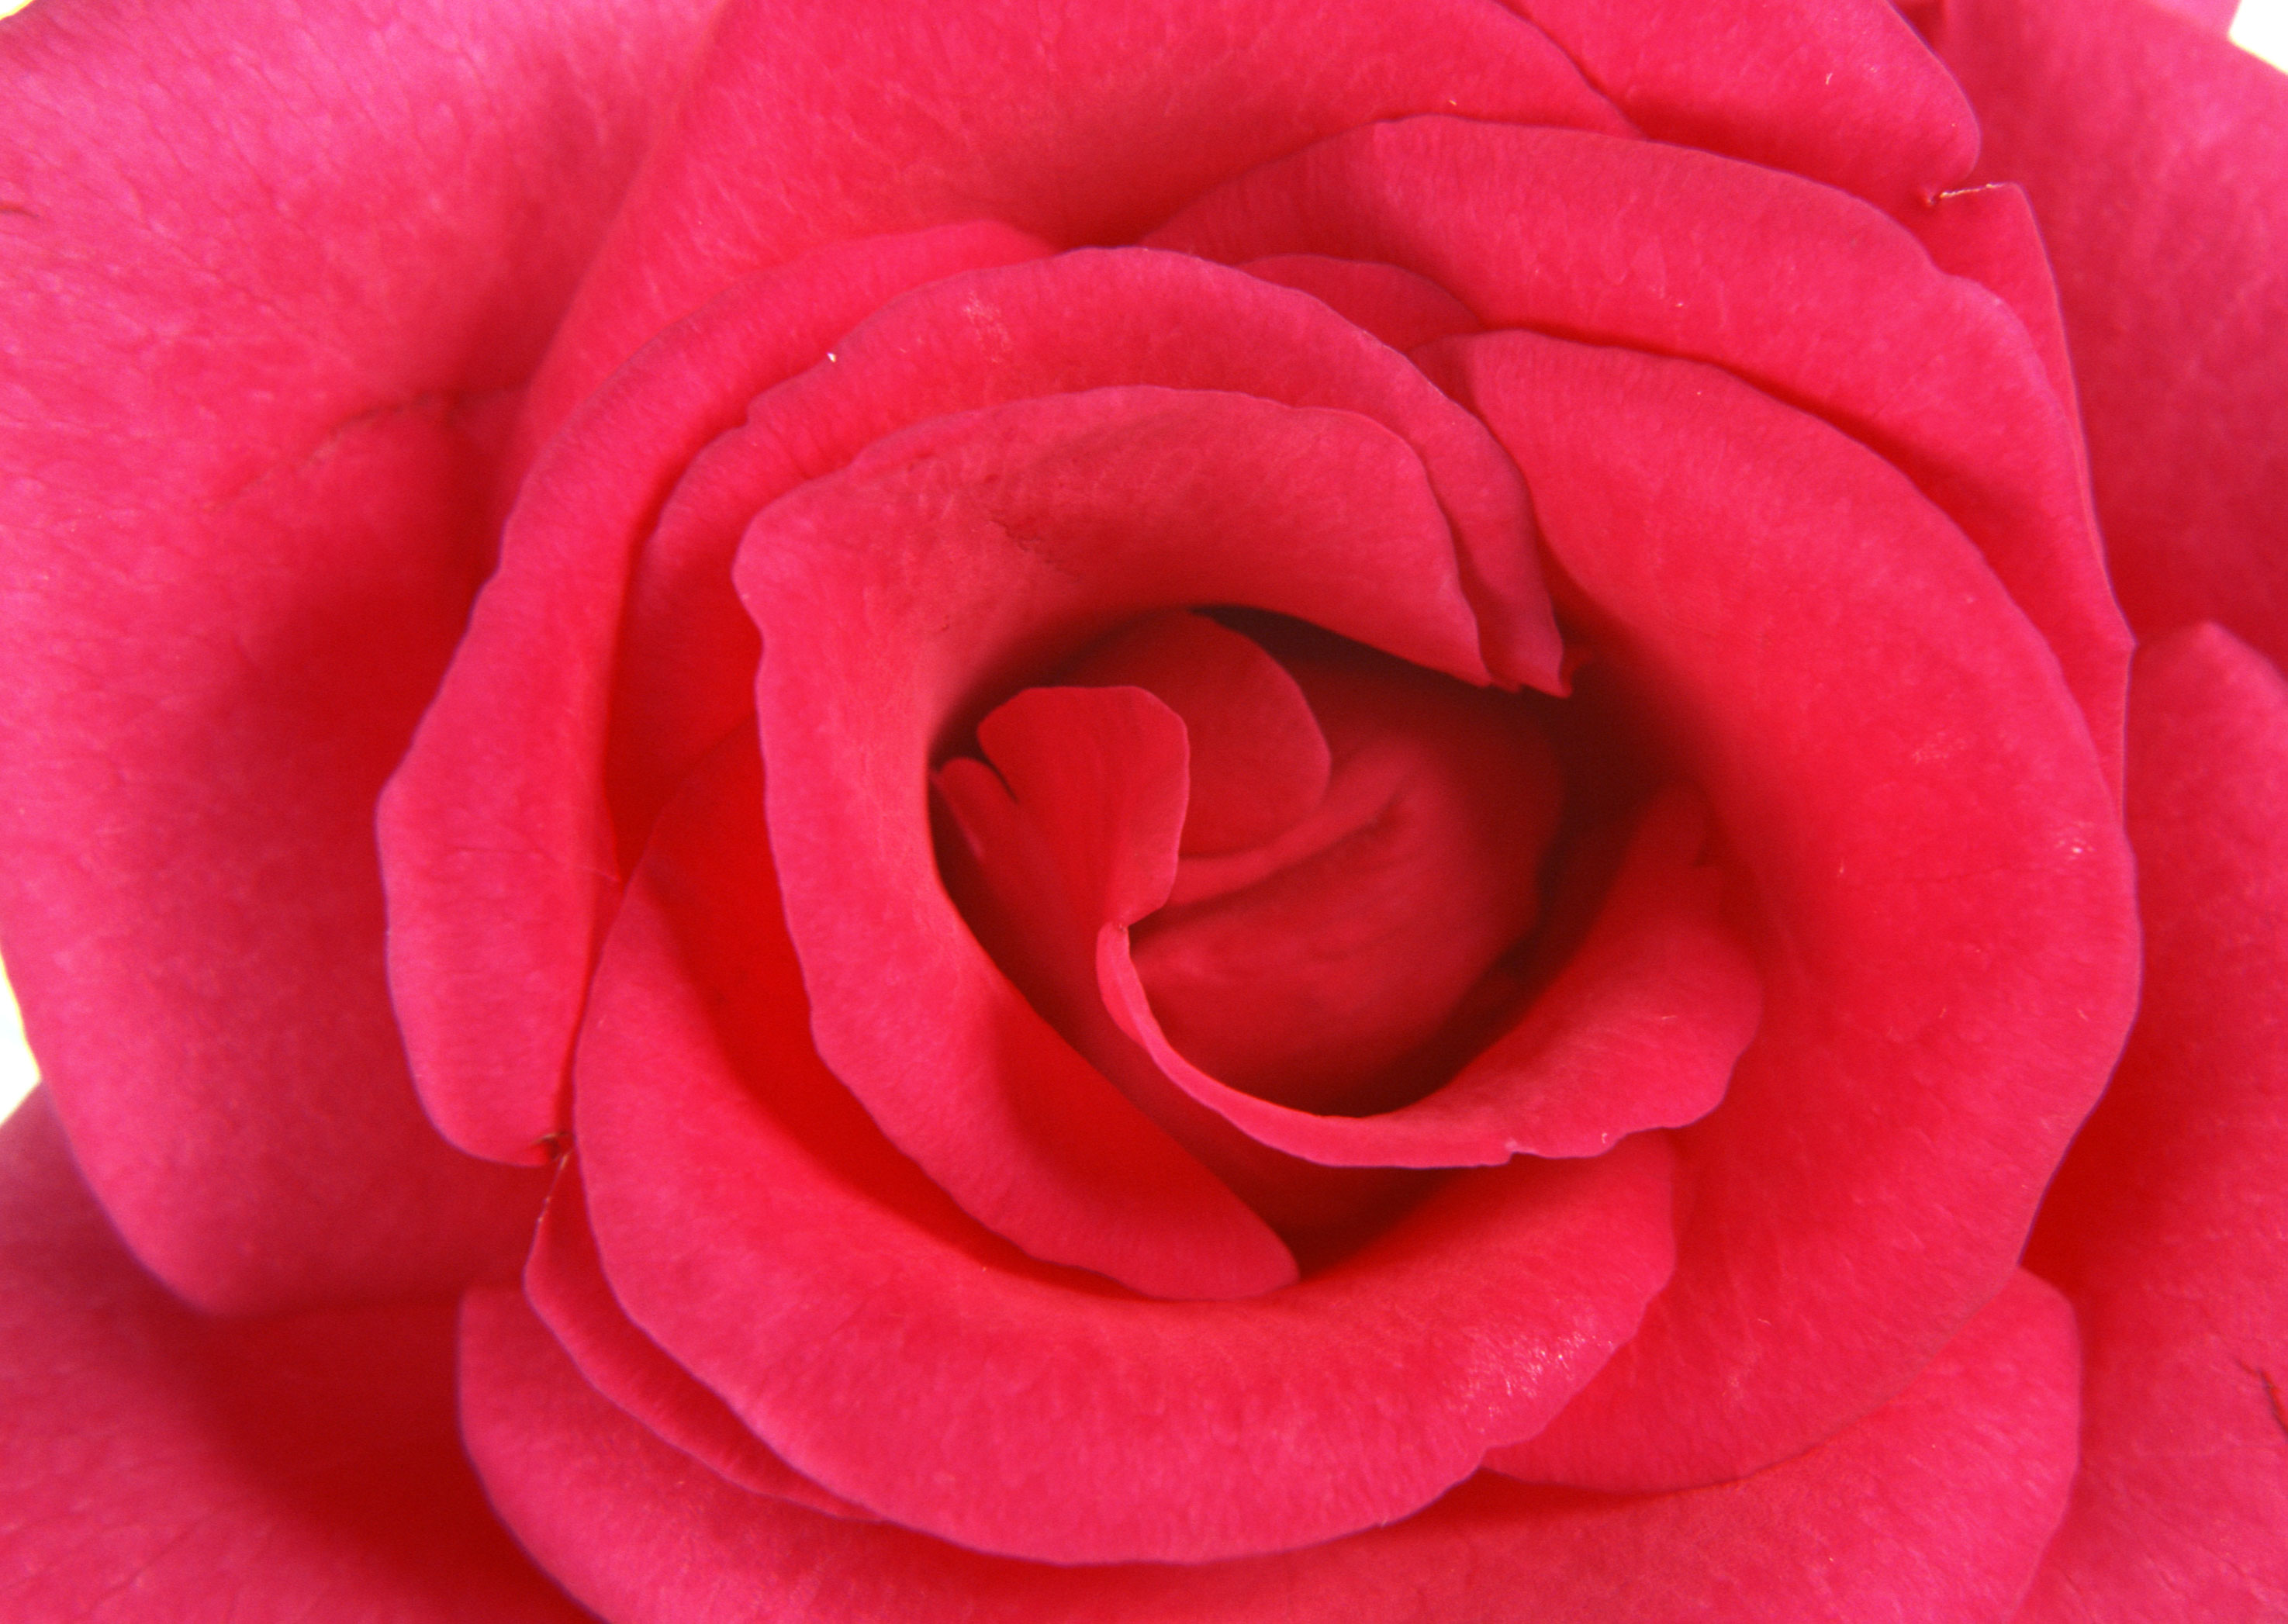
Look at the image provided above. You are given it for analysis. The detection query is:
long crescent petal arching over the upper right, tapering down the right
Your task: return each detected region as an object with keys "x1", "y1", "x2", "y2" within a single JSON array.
[{"x1": 1149, "y1": 119, "x2": 2128, "y2": 786}]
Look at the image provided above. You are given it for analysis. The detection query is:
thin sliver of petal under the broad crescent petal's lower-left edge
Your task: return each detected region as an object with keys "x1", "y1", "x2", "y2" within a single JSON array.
[{"x1": 524, "y1": 1159, "x2": 865, "y2": 1516}]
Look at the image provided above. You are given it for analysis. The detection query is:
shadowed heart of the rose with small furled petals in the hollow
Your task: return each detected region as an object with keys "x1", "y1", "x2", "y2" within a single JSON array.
[{"x1": 938, "y1": 610, "x2": 1560, "y2": 1134}]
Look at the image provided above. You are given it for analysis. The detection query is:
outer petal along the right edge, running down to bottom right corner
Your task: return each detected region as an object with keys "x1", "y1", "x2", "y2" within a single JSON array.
[{"x1": 2027, "y1": 627, "x2": 2288, "y2": 1624}]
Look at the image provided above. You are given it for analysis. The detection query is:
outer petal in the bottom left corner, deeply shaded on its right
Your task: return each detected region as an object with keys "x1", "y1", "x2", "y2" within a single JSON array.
[{"x1": 0, "y1": 1094, "x2": 583, "y2": 1624}]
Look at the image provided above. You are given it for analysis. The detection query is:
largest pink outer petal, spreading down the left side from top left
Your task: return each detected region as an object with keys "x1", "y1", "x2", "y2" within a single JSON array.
[{"x1": 0, "y1": 0, "x2": 718, "y2": 1308}]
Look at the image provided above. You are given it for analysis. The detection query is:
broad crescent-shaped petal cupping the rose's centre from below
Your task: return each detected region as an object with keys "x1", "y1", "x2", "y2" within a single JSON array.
[{"x1": 576, "y1": 736, "x2": 1672, "y2": 1562}]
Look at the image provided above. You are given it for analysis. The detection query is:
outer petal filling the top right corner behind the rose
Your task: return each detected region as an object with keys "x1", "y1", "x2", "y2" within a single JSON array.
[{"x1": 1934, "y1": 0, "x2": 2288, "y2": 663}]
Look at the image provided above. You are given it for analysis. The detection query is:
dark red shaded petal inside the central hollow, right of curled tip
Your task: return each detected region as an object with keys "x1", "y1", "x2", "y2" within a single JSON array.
[{"x1": 1121, "y1": 627, "x2": 1563, "y2": 1111}]
